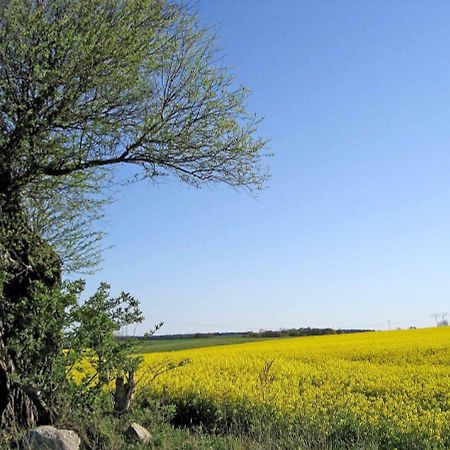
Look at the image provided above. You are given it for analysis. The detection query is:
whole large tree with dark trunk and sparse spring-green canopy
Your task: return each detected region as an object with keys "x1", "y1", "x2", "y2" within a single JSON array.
[{"x1": 0, "y1": 0, "x2": 267, "y2": 428}]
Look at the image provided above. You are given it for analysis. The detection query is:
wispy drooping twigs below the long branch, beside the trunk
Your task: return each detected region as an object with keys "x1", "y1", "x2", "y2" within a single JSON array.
[{"x1": 23, "y1": 172, "x2": 112, "y2": 273}]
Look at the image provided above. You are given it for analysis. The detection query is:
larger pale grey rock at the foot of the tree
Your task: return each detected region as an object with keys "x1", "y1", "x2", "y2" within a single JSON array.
[{"x1": 24, "y1": 425, "x2": 80, "y2": 450}]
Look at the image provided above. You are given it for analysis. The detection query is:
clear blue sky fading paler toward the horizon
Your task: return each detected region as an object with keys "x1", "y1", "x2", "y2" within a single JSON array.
[{"x1": 87, "y1": 0, "x2": 450, "y2": 334}]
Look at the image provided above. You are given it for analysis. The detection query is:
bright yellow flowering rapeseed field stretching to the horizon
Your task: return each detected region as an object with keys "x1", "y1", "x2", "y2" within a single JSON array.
[{"x1": 144, "y1": 327, "x2": 450, "y2": 449}]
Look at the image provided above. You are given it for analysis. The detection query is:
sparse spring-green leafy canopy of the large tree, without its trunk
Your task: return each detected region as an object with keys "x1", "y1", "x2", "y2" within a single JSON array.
[{"x1": 0, "y1": 0, "x2": 267, "y2": 269}]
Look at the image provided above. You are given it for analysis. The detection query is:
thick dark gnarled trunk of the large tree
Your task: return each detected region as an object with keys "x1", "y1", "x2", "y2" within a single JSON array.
[{"x1": 0, "y1": 186, "x2": 61, "y2": 432}]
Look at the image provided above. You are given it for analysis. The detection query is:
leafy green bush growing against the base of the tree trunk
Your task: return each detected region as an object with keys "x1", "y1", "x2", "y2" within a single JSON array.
[{"x1": 0, "y1": 280, "x2": 143, "y2": 421}]
